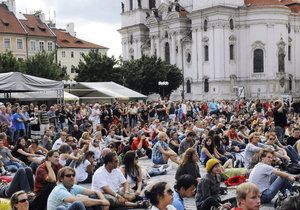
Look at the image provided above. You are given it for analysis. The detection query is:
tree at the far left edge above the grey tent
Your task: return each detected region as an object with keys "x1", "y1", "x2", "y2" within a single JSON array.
[{"x1": 0, "y1": 52, "x2": 20, "y2": 73}]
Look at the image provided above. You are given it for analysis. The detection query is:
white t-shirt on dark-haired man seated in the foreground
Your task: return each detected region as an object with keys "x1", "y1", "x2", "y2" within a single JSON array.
[{"x1": 92, "y1": 165, "x2": 126, "y2": 192}]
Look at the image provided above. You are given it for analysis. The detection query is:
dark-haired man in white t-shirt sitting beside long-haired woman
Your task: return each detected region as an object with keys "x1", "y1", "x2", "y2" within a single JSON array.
[{"x1": 92, "y1": 152, "x2": 149, "y2": 208}]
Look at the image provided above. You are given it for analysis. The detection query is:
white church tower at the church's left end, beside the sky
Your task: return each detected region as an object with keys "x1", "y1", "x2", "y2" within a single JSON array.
[{"x1": 119, "y1": 0, "x2": 156, "y2": 60}]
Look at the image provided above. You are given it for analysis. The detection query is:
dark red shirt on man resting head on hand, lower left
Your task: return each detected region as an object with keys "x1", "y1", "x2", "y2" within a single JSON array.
[{"x1": 34, "y1": 163, "x2": 62, "y2": 194}]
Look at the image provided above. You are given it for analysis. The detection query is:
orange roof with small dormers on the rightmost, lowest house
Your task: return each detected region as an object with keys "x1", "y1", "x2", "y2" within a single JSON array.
[{"x1": 51, "y1": 28, "x2": 108, "y2": 49}]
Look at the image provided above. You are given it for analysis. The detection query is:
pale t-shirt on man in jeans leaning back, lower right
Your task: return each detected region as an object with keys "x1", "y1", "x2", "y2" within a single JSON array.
[{"x1": 249, "y1": 163, "x2": 274, "y2": 193}]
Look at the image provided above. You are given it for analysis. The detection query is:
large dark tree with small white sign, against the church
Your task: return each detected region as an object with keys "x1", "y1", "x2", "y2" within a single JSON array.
[{"x1": 120, "y1": 55, "x2": 183, "y2": 95}]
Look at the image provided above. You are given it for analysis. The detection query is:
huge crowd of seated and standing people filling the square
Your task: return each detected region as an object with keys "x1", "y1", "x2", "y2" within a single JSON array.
[{"x1": 0, "y1": 99, "x2": 300, "y2": 210}]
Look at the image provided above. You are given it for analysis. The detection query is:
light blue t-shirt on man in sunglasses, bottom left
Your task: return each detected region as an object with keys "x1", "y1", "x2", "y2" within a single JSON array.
[{"x1": 47, "y1": 184, "x2": 84, "y2": 210}]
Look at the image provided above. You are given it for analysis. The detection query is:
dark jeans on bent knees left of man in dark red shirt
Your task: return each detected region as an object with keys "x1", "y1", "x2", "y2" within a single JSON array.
[{"x1": 5, "y1": 167, "x2": 33, "y2": 197}]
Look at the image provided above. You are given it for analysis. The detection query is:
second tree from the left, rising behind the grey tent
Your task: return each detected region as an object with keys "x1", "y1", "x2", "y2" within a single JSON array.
[{"x1": 22, "y1": 52, "x2": 68, "y2": 80}]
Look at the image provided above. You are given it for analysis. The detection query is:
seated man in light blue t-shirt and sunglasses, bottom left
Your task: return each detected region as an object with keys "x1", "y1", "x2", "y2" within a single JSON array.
[{"x1": 47, "y1": 166, "x2": 109, "y2": 210}]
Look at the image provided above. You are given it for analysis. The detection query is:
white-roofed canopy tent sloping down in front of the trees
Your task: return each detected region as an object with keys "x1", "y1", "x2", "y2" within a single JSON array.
[{"x1": 70, "y1": 82, "x2": 147, "y2": 100}]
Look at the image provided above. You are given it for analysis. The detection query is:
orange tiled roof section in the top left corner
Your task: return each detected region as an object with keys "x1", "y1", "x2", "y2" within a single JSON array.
[{"x1": 0, "y1": 4, "x2": 26, "y2": 35}]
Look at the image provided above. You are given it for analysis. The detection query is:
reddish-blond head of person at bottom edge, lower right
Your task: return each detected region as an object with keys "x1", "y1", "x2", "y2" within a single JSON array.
[{"x1": 231, "y1": 182, "x2": 260, "y2": 210}]
